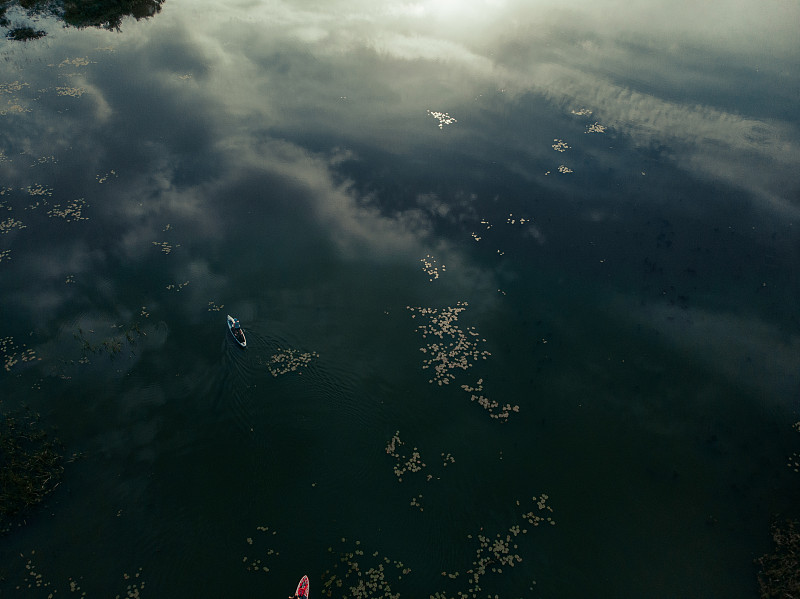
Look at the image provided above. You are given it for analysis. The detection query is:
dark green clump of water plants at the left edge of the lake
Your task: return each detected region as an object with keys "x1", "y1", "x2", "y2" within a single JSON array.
[{"x1": 0, "y1": 409, "x2": 64, "y2": 534}]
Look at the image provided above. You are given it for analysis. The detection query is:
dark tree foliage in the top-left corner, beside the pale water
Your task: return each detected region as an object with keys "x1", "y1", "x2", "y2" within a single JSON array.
[{"x1": 0, "y1": 0, "x2": 164, "y2": 41}]
